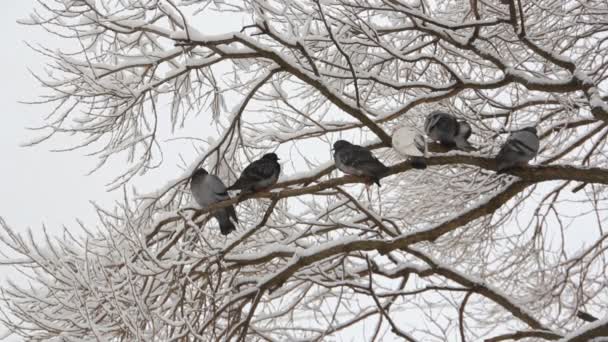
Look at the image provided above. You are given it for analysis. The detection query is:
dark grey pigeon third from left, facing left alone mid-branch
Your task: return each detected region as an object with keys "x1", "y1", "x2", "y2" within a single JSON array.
[{"x1": 334, "y1": 140, "x2": 388, "y2": 186}]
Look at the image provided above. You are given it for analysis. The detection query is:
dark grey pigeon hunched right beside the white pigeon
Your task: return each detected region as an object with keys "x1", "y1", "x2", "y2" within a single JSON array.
[{"x1": 424, "y1": 111, "x2": 474, "y2": 151}]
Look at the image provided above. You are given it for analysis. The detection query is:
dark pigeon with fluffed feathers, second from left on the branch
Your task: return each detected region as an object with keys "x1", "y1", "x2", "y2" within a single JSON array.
[{"x1": 228, "y1": 153, "x2": 281, "y2": 192}]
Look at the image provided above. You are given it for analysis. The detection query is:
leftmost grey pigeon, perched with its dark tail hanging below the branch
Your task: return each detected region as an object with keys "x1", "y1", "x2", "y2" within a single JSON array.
[{"x1": 190, "y1": 168, "x2": 238, "y2": 235}]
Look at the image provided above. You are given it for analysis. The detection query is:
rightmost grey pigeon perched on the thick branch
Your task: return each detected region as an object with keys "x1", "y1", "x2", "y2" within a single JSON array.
[{"x1": 496, "y1": 127, "x2": 540, "y2": 173}]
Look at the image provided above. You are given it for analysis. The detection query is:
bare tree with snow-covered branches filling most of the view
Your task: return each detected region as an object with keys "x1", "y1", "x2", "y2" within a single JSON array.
[{"x1": 0, "y1": 0, "x2": 608, "y2": 341}]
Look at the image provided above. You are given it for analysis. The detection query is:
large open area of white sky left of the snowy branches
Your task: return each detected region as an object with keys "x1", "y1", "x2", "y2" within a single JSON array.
[{"x1": 0, "y1": 0, "x2": 118, "y2": 231}]
